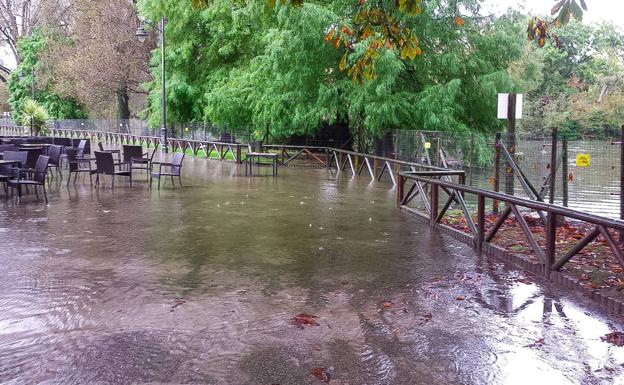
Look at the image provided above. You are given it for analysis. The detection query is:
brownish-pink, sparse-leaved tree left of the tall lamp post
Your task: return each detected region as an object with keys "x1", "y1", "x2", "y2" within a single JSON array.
[{"x1": 46, "y1": 0, "x2": 154, "y2": 119}]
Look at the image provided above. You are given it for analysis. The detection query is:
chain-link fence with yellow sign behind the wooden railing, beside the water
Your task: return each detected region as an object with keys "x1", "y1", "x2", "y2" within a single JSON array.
[{"x1": 393, "y1": 130, "x2": 621, "y2": 218}]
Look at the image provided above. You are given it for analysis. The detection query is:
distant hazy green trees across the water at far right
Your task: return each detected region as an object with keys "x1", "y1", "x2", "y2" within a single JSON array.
[{"x1": 511, "y1": 21, "x2": 624, "y2": 137}]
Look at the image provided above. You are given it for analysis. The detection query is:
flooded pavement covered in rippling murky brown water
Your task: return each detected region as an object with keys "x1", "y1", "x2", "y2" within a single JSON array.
[{"x1": 0, "y1": 158, "x2": 624, "y2": 385}]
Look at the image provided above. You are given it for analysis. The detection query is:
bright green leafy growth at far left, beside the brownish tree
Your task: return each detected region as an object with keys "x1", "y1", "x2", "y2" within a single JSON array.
[{"x1": 8, "y1": 29, "x2": 87, "y2": 121}]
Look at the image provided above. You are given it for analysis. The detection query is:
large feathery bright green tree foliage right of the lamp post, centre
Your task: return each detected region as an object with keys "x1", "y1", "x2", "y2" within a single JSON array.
[{"x1": 139, "y1": 0, "x2": 523, "y2": 144}]
